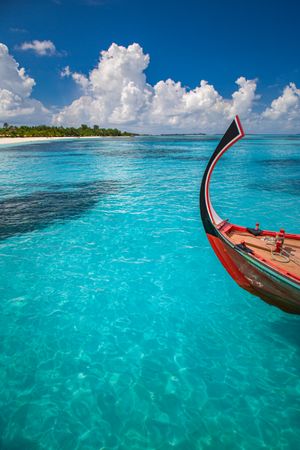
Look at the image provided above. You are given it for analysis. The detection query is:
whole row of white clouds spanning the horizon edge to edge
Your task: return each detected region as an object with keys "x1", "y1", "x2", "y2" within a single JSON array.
[{"x1": 0, "y1": 41, "x2": 300, "y2": 133}]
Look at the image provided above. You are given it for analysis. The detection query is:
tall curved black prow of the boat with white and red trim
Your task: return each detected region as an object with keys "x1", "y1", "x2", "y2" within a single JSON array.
[{"x1": 200, "y1": 116, "x2": 245, "y2": 236}]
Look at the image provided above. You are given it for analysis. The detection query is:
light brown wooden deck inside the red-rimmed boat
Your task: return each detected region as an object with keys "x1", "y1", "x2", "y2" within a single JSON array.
[{"x1": 226, "y1": 229, "x2": 300, "y2": 279}]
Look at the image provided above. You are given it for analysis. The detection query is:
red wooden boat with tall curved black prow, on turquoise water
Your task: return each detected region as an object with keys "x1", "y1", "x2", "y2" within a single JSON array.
[{"x1": 200, "y1": 117, "x2": 300, "y2": 314}]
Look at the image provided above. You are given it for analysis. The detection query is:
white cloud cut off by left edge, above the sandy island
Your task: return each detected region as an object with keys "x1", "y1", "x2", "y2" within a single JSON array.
[{"x1": 0, "y1": 43, "x2": 49, "y2": 123}]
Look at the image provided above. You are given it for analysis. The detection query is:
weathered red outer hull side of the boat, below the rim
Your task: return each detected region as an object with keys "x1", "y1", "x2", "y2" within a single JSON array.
[{"x1": 207, "y1": 234, "x2": 300, "y2": 314}]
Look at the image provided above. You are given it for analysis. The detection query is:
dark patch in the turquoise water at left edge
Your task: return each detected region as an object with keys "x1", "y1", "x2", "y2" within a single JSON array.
[{"x1": 0, "y1": 180, "x2": 124, "y2": 240}]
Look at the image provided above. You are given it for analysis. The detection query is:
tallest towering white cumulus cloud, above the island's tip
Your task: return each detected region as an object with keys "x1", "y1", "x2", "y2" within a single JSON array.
[{"x1": 54, "y1": 44, "x2": 153, "y2": 126}]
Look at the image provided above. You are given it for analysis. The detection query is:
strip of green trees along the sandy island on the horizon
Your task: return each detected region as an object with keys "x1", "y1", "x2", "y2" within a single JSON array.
[{"x1": 0, "y1": 123, "x2": 135, "y2": 138}]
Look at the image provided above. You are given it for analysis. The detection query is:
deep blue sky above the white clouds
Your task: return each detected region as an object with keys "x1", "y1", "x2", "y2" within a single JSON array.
[{"x1": 0, "y1": 0, "x2": 300, "y2": 132}]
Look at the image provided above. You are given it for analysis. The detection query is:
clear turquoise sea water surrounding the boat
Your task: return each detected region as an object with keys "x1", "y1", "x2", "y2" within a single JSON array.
[{"x1": 0, "y1": 136, "x2": 300, "y2": 450}]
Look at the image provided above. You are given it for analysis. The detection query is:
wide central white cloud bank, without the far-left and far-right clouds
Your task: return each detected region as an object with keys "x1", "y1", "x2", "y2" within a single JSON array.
[{"x1": 53, "y1": 44, "x2": 257, "y2": 132}]
